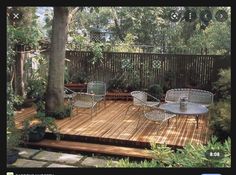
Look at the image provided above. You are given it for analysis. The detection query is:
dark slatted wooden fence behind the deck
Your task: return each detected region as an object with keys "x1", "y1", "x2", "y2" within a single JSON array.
[{"x1": 66, "y1": 51, "x2": 231, "y2": 89}]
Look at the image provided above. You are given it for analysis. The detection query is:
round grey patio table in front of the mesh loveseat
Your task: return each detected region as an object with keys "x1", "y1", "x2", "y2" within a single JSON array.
[{"x1": 159, "y1": 102, "x2": 208, "y2": 128}]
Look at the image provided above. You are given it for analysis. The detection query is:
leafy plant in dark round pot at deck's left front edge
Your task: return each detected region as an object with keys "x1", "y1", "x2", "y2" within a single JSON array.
[{"x1": 23, "y1": 111, "x2": 60, "y2": 142}]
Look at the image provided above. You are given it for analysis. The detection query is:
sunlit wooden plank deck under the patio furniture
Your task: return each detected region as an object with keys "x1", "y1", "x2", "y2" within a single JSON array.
[{"x1": 15, "y1": 100, "x2": 208, "y2": 150}]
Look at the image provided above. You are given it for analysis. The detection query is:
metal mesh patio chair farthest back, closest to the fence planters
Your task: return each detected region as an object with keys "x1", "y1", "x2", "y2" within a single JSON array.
[{"x1": 87, "y1": 81, "x2": 106, "y2": 105}]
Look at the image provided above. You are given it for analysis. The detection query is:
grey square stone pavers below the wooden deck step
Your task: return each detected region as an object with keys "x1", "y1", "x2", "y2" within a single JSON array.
[{"x1": 8, "y1": 148, "x2": 117, "y2": 168}]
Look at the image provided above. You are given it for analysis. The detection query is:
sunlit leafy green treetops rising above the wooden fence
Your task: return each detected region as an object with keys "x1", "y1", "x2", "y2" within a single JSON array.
[{"x1": 67, "y1": 7, "x2": 231, "y2": 54}]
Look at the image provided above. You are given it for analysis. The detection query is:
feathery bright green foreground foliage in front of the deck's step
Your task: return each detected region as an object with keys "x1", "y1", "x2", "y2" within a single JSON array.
[{"x1": 112, "y1": 137, "x2": 231, "y2": 168}]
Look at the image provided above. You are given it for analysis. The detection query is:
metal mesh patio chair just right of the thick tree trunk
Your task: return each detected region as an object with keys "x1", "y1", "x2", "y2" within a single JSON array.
[{"x1": 72, "y1": 92, "x2": 97, "y2": 118}]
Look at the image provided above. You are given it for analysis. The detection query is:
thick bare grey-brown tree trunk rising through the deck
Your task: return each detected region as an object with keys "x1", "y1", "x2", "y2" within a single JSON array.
[{"x1": 46, "y1": 7, "x2": 69, "y2": 114}]
